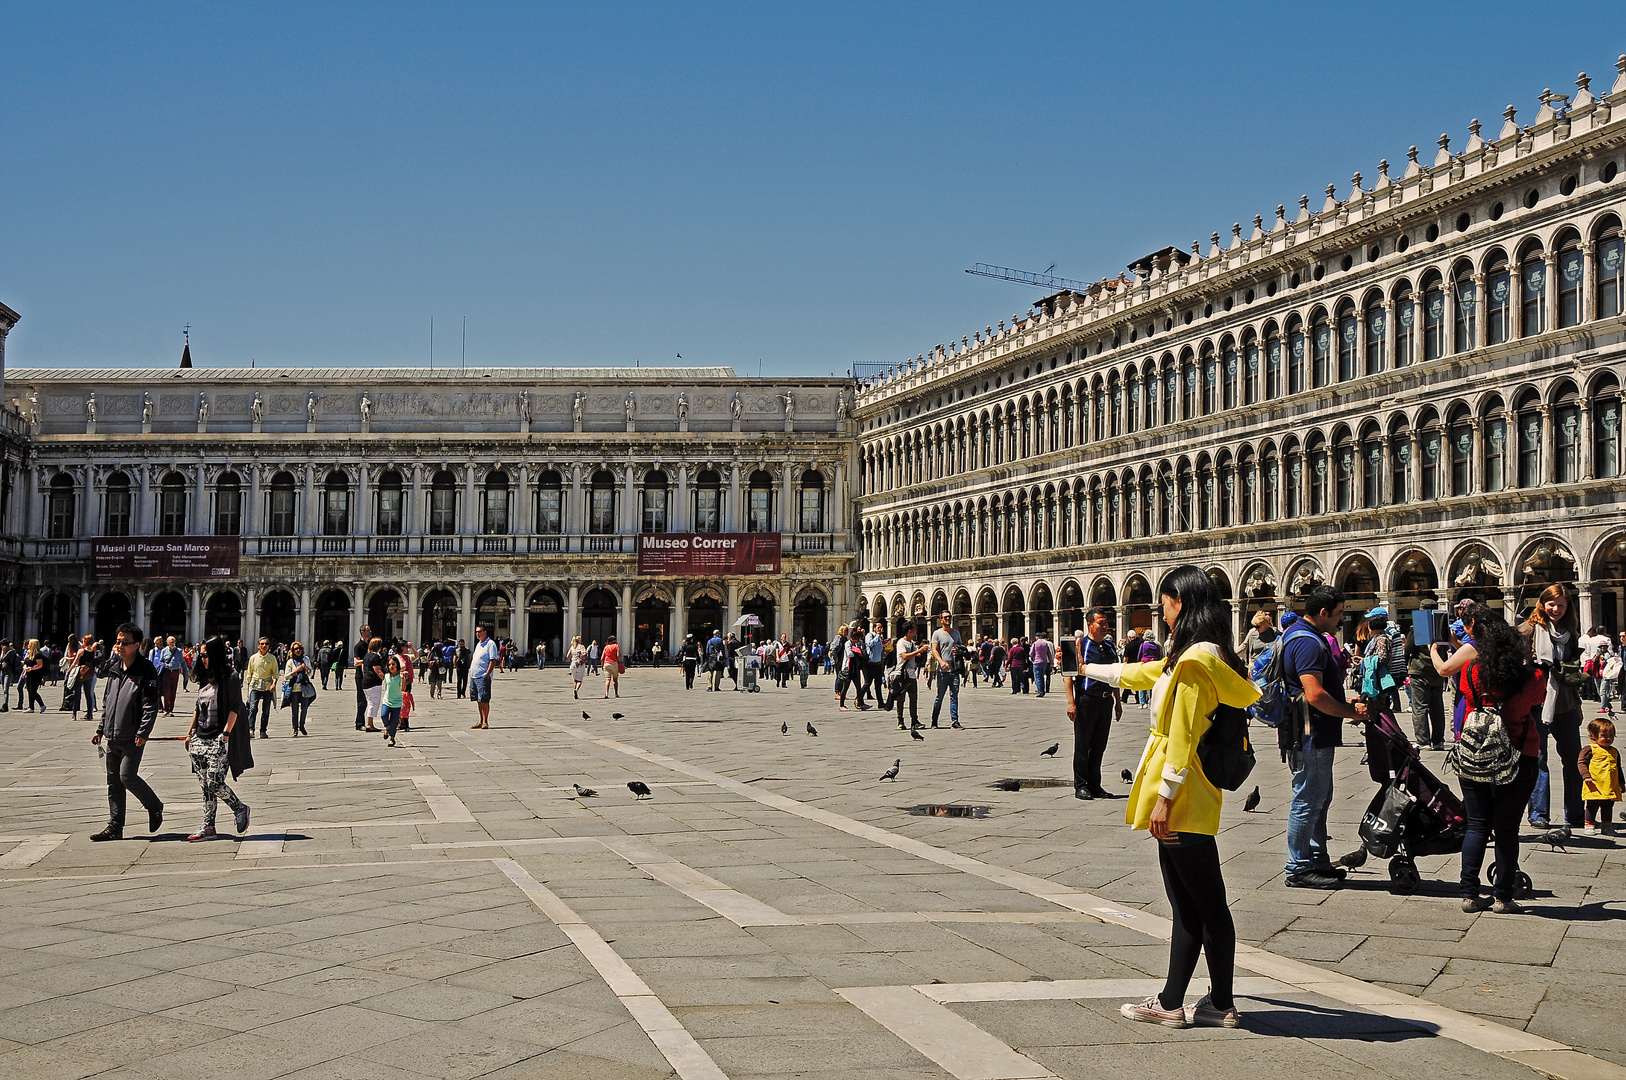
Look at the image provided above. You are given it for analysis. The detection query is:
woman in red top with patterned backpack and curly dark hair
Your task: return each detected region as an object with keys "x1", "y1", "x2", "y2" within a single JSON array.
[{"x1": 1457, "y1": 603, "x2": 1546, "y2": 916}]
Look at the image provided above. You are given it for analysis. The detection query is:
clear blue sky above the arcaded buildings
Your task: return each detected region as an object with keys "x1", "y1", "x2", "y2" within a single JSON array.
[{"x1": 0, "y1": 0, "x2": 1626, "y2": 374}]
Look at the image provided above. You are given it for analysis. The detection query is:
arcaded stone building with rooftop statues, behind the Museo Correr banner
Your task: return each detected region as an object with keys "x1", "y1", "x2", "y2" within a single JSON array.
[{"x1": 5, "y1": 368, "x2": 855, "y2": 647}]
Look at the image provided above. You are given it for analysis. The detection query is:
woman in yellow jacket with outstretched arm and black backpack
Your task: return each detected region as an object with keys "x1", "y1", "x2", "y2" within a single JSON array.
[{"x1": 1083, "y1": 564, "x2": 1259, "y2": 1028}]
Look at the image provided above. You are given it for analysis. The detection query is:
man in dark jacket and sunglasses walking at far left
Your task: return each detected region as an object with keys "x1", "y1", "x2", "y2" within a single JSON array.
[{"x1": 91, "y1": 623, "x2": 164, "y2": 841}]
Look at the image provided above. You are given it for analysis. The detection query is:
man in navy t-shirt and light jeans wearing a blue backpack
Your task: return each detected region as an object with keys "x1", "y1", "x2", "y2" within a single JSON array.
[{"x1": 1276, "y1": 586, "x2": 1366, "y2": 888}]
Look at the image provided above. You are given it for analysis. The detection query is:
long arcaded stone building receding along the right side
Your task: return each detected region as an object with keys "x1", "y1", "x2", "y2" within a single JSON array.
[{"x1": 854, "y1": 57, "x2": 1626, "y2": 636}]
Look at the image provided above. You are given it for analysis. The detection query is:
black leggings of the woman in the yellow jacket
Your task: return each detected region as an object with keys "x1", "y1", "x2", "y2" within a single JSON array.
[{"x1": 1158, "y1": 833, "x2": 1236, "y2": 1008}]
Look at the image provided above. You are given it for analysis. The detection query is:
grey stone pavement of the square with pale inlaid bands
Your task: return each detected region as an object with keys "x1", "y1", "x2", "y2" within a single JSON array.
[{"x1": 0, "y1": 667, "x2": 1626, "y2": 1080}]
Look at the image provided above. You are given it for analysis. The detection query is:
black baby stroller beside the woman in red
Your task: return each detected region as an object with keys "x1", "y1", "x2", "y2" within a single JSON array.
[{"x1": 1338, "y1": 701, "x2": 1489, "y2": 896}]
